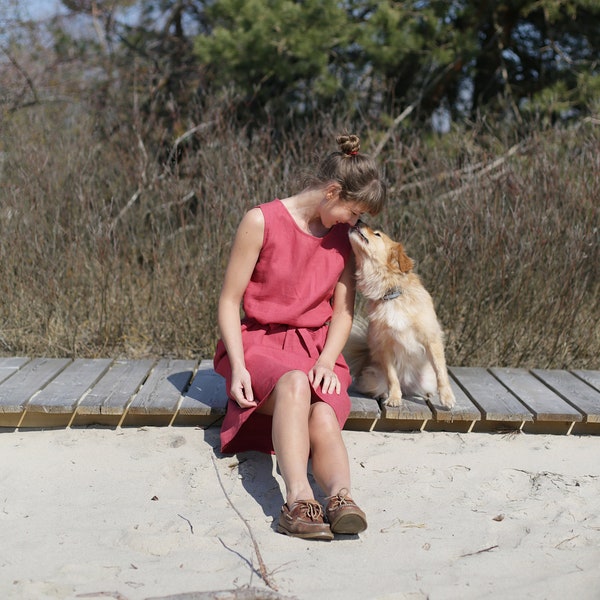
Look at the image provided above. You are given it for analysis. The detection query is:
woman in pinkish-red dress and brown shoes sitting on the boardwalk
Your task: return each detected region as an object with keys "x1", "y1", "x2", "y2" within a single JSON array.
[{"x1": 214, "y1": 135, "x2": 386, "y2": 540}]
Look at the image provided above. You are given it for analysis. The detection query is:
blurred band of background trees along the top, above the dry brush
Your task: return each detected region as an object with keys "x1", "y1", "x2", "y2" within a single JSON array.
[{"x1": 0, "y1": 0, "x2": 600, "y2": 150}]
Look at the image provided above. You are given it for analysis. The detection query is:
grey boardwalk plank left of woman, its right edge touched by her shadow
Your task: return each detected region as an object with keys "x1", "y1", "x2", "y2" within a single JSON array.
[{"x1": 124, "y1": 358, "x2": 196, "y2": 425}]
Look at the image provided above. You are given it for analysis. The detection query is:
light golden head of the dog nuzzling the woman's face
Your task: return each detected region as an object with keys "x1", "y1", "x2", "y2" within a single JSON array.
[{"x1": 350, "y1": 221, "x2": 414, "y2": 274}]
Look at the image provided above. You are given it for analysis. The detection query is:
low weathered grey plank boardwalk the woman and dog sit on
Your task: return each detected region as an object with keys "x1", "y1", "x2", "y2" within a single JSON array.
[{"x1": 0, "y1": 357, "x2": 600, "y2": 435}]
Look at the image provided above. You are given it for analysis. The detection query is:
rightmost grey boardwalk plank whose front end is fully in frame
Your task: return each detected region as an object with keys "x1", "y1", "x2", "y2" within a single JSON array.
[{"x1": 490, "y1": 368, "x2": 583, "y2": 433}]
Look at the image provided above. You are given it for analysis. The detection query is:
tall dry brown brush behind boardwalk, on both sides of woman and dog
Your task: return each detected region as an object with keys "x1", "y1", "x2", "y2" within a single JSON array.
[{"x1": 0, "y1": 108, "x2": 600, "y2": 369}]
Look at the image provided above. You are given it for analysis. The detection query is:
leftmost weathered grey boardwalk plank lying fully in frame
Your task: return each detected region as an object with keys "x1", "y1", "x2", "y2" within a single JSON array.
[{"x1": 27, "y1": 358, "x2": 112, "y2": 414}]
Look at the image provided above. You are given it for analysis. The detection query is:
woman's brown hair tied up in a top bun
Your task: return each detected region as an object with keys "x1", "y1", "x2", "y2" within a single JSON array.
[{"x1": 312, "y1": 135, "x2": 387, "y2": 215}]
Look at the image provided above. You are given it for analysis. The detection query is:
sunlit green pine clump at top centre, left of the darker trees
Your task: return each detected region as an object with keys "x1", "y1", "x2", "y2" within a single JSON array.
[{"x1": 194, "y1": 0, "x2": 348, "y2": 112}]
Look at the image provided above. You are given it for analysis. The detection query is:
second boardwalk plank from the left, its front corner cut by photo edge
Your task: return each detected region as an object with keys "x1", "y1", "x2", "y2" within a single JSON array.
[{"x1": 0, "y1": 358, "x2": 71, "y2": 414}]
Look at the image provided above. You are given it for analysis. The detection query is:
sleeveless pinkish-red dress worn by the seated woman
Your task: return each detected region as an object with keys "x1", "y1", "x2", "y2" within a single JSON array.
[{"x1": 214, "y1": 200, "x2": 352, "y2": 453}]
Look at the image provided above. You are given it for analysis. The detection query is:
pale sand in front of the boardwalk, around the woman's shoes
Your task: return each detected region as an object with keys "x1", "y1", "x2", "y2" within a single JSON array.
[{"x1": 0, "y1": 427, "x2": 600, "y2": 600}]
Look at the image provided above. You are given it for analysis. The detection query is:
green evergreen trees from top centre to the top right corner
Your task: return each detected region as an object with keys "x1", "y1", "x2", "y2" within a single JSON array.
[{"x1": 195, "y1": 0, "x2": 600, "y2": 124}]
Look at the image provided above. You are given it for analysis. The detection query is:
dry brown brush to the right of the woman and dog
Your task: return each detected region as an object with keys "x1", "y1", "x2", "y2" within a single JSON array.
[{"x1": 378, "y1": 127, "x2": 600, "y2": 368}]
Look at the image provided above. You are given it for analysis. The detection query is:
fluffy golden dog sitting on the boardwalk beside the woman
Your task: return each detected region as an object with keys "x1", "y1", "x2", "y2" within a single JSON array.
[{"x1": 344, "y1": 221, "x2": 455, "y2": 408}]
